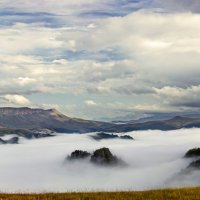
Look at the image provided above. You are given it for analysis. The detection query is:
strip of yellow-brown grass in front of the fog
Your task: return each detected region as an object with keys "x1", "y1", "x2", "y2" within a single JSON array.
[{"x1": 0, "y1": 188, "x2": 200, "y2": 200}]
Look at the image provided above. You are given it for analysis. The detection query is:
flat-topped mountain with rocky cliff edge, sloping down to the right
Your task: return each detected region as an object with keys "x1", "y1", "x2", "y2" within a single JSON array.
[{"x1": 0, "y1": 107, "x2": 110, "y2": 133}]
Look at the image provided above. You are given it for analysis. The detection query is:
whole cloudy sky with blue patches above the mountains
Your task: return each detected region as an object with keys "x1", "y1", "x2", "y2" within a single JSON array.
[{"x1": 0, "y1": 0, "x2": 200, "y2": 119}]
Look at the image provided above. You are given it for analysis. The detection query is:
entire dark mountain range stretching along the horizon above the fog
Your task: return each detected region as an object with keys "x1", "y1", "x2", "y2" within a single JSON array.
[{"x1": 0, "y1": 107, "x2": 200, "y2": 133}]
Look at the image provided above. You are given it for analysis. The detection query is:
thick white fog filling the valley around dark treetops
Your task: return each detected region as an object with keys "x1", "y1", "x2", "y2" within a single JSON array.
[{"x1": 0, "y1": 129, "x2": 200, "y2": 192}]
